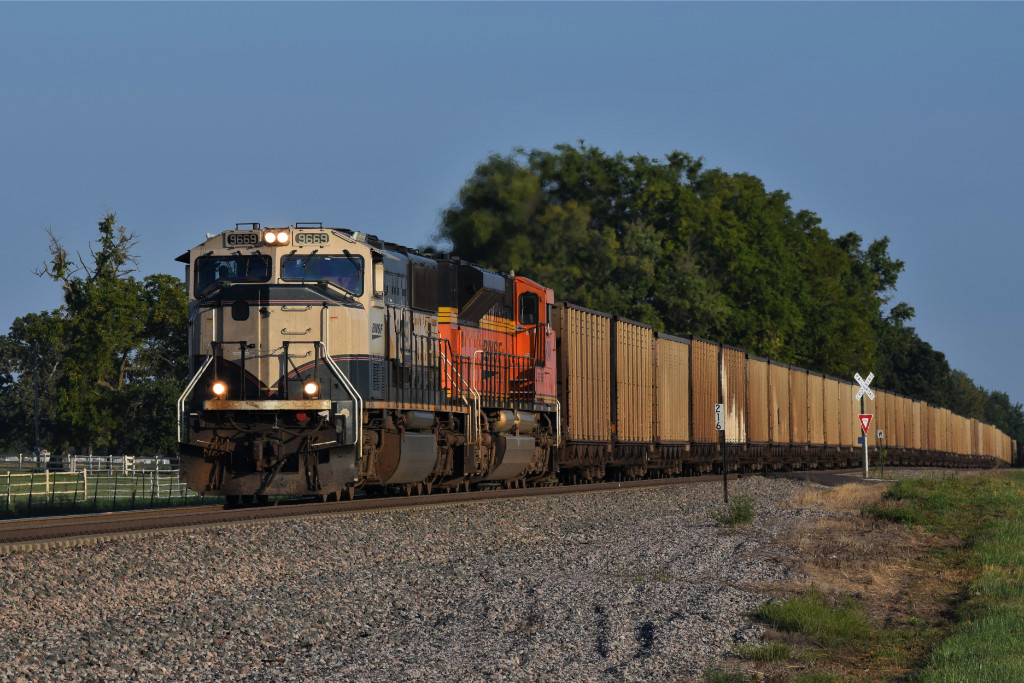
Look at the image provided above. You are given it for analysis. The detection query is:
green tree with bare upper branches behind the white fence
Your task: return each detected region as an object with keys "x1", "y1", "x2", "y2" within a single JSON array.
[{"x1": 0, "y1": 213, "x2": 187, "y2": 454}]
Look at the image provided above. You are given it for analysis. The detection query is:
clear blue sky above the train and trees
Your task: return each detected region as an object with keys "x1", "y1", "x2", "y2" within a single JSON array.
[{"x1": 0, "y1": 2, "x2": 1024, "y2": 401}]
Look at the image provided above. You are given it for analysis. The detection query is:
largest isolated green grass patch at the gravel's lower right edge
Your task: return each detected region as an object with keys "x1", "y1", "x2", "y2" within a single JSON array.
[{"x1": 754, "y1": 588, "x2": 871, "y2": 647}]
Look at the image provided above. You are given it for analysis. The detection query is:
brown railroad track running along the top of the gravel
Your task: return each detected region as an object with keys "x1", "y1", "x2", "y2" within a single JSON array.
[{"x1": 0, "y1": 470, "x2": 880, "y2": 554}]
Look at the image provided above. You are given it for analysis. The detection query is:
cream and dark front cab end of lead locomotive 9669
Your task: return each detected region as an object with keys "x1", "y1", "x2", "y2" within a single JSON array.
[{"x1": 178, "y1": 223, "x2": 373, "y2": 497}]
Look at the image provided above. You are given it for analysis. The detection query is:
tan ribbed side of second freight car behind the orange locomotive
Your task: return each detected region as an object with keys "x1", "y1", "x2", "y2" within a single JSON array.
[{"x1": 614, "y1": 319, "x2": 654, "y2": 443}]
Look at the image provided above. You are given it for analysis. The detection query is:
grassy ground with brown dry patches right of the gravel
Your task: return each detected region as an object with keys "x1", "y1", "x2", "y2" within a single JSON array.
[{"x1": 705, "y1": 472, "x2": 1024, "y2": 683}]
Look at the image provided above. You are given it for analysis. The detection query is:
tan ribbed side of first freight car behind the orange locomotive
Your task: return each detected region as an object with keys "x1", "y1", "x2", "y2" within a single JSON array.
[{"x1": 553, "y1": 304, "x2": 612, "y2": 442}]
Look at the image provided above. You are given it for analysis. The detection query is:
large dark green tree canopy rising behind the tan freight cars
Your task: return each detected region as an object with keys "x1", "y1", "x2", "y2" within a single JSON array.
[{"x1": 435, "y1": 140, "x2": 1024, "y2": 439}]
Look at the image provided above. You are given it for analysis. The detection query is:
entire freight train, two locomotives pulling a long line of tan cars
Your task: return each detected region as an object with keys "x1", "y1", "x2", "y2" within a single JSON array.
[{"x1": 177, "y1": 223, "x2": 1017, "y2": 501}]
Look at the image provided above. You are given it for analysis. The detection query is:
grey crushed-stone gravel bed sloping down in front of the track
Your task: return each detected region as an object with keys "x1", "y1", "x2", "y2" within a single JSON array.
[{"x1": 0, "y1": 476, "x2": 827, "y2": 681}]
